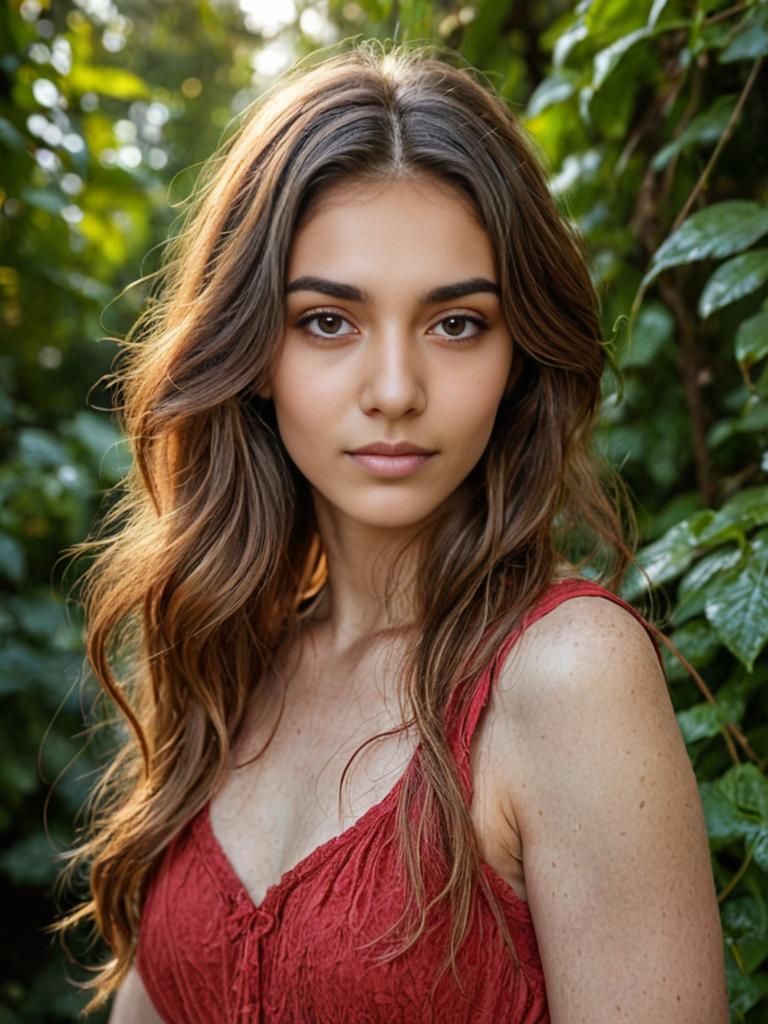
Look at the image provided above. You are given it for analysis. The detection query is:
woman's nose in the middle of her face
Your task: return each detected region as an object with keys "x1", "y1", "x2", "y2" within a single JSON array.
[{"x1": 359, "y1": 328, "x2": 426, "y2": 420}]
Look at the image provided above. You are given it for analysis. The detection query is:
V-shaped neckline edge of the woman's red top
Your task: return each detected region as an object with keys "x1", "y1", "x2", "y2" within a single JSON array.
[{"x1": 196, "y1": 741, "x2": 422, "y2": 913}]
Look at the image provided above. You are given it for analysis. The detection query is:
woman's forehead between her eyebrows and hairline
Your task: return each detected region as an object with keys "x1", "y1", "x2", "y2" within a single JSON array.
[{"x1": 289, "y1": 176, "x2": 495, "y2": 283}]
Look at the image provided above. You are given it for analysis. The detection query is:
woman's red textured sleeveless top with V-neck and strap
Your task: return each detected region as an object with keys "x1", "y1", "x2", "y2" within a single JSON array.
[{"x1": 136, "y1": 580, "x2": 662, "y2": 1024}]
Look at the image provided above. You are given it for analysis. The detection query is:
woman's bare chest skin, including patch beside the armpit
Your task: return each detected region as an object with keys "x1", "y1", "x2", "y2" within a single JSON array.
[{"x1": 210, "y1": 634, "x2": 525, "y2": 904}]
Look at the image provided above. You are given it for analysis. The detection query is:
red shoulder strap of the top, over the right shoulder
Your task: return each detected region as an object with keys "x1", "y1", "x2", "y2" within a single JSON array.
[{"x1": 452, "y1": 578, "x2": 665, "y2": 797}]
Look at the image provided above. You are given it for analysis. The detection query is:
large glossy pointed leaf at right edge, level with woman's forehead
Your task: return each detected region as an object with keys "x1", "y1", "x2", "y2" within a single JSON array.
[{"x1": 641, "y1": 199, "x2": 768, "y2": 287}]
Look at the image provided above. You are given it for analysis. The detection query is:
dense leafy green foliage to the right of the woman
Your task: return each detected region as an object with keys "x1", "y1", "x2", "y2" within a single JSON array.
[{"x1": 487, "y1": 0, "x2": 768, "y2": 1021}]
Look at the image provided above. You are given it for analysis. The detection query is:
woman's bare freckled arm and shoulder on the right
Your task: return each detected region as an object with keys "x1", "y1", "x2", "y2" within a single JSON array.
[{"x1": 497, "y1": 596, "x2": 728, "y2": 1024}]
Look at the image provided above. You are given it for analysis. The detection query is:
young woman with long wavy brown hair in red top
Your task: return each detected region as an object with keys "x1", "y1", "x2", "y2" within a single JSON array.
[{"x1": 57, "y1": 43, "x2": 728, "y2": 1024}]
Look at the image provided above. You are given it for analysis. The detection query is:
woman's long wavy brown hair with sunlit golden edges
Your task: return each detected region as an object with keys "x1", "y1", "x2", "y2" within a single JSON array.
[{"x1": 50, "y1": 41, "x2": 667, "y2": 1012}]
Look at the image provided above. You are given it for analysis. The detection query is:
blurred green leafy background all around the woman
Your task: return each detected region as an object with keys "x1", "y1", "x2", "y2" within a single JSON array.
[{"x1": 0, "y1": 0, "x2": 768, "y2": 1024}]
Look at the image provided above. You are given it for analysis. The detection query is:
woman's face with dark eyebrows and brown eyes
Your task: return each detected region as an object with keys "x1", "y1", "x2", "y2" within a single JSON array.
[{"x1": 261, "y1": 178, "x2": 520, "y2": 528}]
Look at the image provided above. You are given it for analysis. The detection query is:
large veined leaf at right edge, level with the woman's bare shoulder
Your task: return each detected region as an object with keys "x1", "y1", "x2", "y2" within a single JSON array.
[{"x1": 705, "y1": 548, "x2": 768, "y2": 671}]
